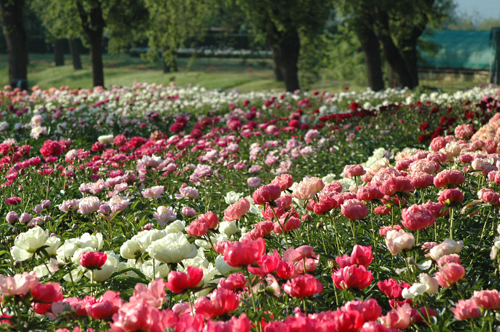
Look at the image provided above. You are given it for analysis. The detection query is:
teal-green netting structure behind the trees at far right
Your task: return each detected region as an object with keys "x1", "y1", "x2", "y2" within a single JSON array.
[{"x1": 419, "y1": 30, "x2": 492, "y2": 70}]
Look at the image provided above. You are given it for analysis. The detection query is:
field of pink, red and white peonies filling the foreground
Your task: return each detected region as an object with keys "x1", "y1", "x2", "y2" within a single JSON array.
[{"x1": 0, "y1": 84, "x2": 500, "y2": 332}]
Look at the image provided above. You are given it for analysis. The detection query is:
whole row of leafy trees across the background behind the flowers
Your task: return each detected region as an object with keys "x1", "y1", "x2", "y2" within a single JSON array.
[{"x1": 0, "y1": 0, "x2": 480, "y2": 91}]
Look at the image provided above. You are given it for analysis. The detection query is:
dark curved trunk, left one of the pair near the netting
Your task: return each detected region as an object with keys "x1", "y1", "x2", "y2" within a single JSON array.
[{"x1": 356, "y1": 22, "x2": 384, "y2": 91}]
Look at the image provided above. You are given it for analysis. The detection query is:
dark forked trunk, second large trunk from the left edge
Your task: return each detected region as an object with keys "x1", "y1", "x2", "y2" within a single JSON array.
[{"x1": 76, "y1": 1, "x2": 106, "y2": 87}]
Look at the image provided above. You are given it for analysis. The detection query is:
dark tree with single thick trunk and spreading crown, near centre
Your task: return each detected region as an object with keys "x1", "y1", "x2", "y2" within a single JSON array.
[{"x1": 234, "y1": 0, "x2": 333, "y2": 91}]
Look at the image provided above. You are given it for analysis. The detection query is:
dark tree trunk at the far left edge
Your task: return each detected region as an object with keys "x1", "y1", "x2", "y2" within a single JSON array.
[{"x1": 0, "y1": 0, "x2": 28, "y2": 90}]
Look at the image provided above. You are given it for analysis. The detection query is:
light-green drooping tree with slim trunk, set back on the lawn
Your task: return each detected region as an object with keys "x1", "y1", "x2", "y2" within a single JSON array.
[{"x1": 145, "y1": 0, "x2": 213, "y2": 73}]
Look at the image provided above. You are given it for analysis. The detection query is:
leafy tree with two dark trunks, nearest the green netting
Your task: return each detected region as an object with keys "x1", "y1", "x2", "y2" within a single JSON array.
[{"x1": 337, "y1": 0, "x2": 453, "y2": 90}]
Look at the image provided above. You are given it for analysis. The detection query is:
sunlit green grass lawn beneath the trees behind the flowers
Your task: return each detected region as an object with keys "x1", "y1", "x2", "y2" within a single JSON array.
[{"x1": 0, "y1": 54, "x2": 486, "y2": 93}]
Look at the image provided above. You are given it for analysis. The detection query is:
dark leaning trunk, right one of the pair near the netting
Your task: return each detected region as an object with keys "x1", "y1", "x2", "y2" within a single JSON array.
[{"x1": 377, "y1": 10, "x2": 415, "y2": 89}]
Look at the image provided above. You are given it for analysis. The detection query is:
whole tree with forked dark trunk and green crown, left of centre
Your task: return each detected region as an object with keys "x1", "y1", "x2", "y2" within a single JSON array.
[{"x1": 32, "y1": 0, "x2": 148, "y2": 86}]
